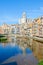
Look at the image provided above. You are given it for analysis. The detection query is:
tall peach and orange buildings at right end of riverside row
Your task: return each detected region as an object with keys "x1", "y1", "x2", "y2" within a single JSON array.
[{"x1": 32, "y1": 17, "x2": 43, "y2": 37}]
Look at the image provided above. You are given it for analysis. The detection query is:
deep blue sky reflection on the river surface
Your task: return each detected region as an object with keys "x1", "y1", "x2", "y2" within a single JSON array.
[{"x1": 0, "y1": 44, "x2": 31, "y2": 63}]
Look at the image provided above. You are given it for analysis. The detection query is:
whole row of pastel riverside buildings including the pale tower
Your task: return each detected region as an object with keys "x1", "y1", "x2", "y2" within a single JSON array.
[{"x1": 0, "y1": 12, "x2": 43, "y2": 37}]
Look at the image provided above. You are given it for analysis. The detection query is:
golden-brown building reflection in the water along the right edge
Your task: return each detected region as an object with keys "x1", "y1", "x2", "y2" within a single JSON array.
[{"x1": 32, "y1": 41, "x2": 43, "y2": 60}]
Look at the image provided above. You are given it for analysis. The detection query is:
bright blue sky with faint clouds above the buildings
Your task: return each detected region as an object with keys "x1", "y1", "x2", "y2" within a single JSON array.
[{"x1": 0, "y1": 0, "x2": 43, "y2": 25}]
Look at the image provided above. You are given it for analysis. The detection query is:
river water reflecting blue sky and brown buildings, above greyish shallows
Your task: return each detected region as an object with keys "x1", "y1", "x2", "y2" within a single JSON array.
[{"x1": 0, "y1": 37, "x2": 43, "y2": 63}]
